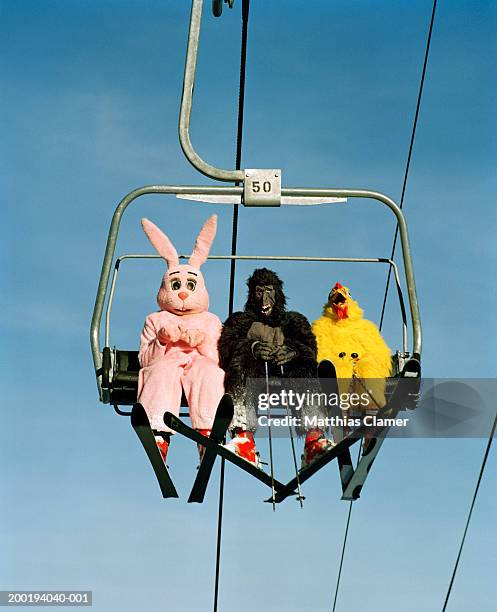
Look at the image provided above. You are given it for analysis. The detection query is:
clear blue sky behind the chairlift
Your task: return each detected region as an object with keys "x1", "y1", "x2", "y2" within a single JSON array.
[{"x1": 0, "y1": 0, "x2": 497, "y2": 612}]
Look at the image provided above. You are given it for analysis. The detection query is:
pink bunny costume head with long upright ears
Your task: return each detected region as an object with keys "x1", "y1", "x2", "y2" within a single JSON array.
[{"x1": 142, "y1": 215, "x2": 217, "y2": 316}]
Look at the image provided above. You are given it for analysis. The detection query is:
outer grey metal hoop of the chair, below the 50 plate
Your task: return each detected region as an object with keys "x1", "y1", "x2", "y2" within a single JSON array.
[{"x1": 90, "y1": 185, "x2": 422, "y2": 400}]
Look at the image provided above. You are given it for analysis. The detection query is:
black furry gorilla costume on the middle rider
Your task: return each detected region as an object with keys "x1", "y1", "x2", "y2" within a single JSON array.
[{"x1": 219, "y1": 268, "x2": 326, "y2": 435}]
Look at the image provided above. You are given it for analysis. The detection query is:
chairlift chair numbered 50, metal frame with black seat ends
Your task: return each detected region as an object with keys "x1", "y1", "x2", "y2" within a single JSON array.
[{"x1": 90, "y1": 0, "x2": 421, "y2": 505}]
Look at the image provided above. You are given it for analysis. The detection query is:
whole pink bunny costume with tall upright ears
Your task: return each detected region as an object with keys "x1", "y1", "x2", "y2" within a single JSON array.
[{"x1": 138, "y1": 215, "x2": 224, "y2": 433}]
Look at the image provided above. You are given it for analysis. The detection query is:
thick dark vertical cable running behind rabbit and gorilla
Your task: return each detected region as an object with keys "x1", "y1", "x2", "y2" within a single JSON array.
[{"x1": 214, "y1": 0, "x2": 250, "y2": 612}]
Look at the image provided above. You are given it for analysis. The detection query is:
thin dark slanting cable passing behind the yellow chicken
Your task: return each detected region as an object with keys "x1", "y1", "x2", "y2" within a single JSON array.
[{"x1": 333, "y1": 0, "x2": 436, "y2": 612}]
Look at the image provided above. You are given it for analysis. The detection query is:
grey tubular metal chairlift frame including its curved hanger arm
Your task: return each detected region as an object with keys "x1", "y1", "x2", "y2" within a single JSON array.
[{"x1": 90, "y1": 0, "x2": 422, "y2": 499}]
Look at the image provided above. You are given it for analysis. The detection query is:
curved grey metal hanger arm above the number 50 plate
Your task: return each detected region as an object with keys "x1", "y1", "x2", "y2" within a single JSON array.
[{"x1": 179, "y1": 0, "x2": 245, "y2": 182}]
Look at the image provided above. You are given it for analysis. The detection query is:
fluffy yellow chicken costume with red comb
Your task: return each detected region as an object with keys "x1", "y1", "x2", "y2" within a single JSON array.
[{"x1": 312, "y1": 283, "x2": 392, "y2": 409}]
